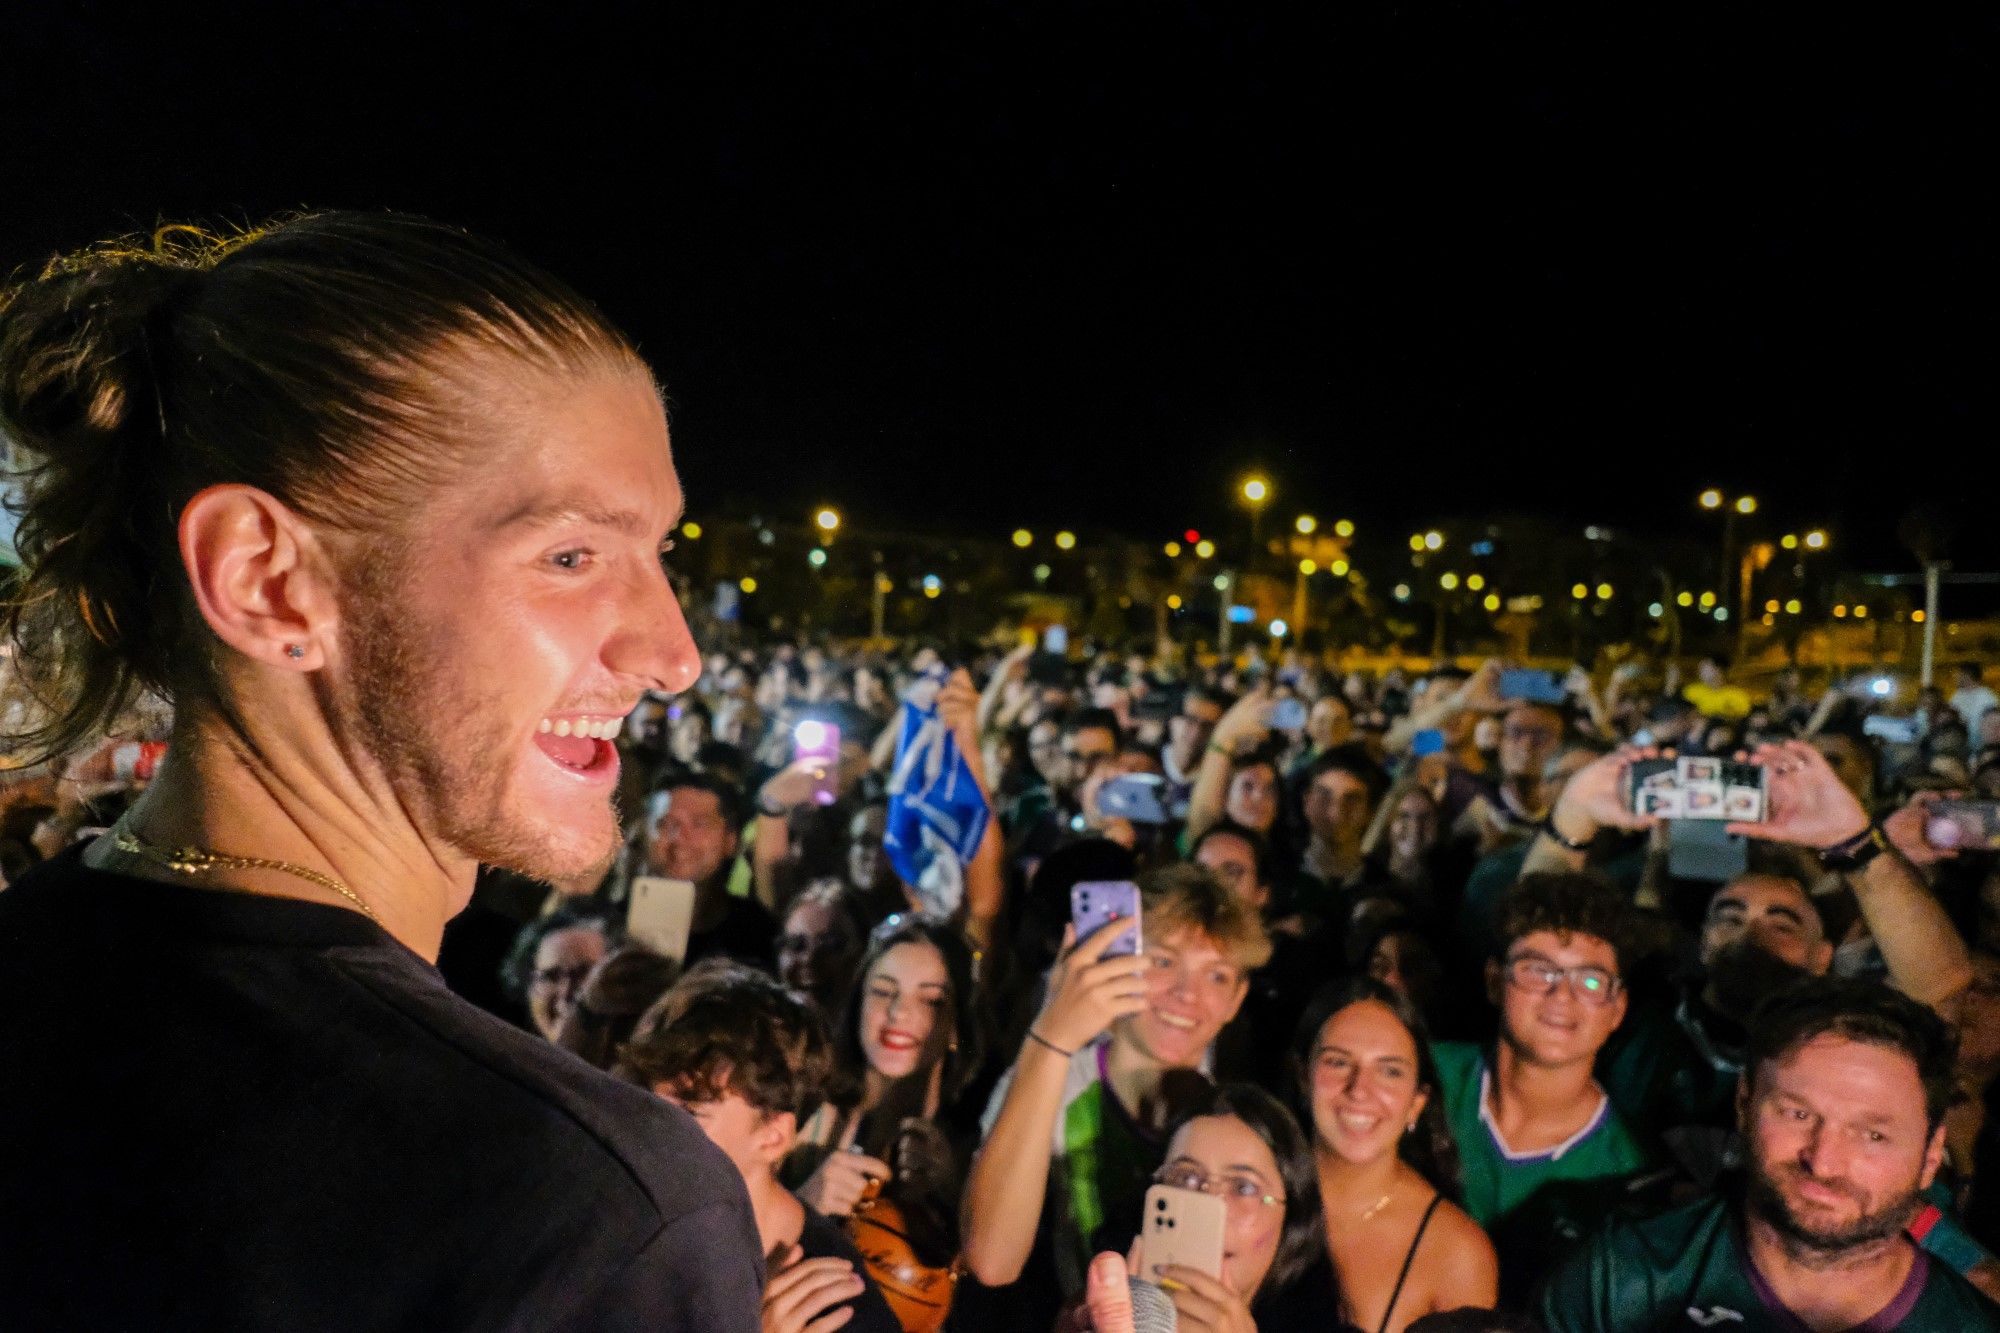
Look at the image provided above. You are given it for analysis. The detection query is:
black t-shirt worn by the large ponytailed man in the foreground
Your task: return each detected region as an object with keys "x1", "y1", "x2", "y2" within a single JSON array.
[{"x1": 0, "y1": 853, "x2": 762, "y2": 1333}]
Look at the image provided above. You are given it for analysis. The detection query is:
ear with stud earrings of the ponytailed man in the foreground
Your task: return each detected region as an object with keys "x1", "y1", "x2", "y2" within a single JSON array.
[{"x1": 178, "y1": 484, "x2": 336, "y2": 671}]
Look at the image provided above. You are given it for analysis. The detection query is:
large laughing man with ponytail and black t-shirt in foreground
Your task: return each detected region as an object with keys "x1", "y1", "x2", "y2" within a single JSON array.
[{"x1": 0, "y1": 214, "x2": 760, "y2": 1329}]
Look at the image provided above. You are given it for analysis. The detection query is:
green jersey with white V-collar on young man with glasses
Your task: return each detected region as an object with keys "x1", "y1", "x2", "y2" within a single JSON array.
[{"x1": 1432, "y1": 1041, "x2": 1652, "y2": 1229}]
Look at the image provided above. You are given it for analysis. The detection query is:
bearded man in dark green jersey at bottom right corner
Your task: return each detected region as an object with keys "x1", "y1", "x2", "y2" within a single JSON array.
[{"x1": 1538, "y1": 979, "x2": 2000, "y2": 1333}]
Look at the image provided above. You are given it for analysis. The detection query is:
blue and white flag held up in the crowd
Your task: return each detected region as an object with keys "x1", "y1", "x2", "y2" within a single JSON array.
[{"x1": 882, "y1": 701, "x2": 992, "y2": 917}]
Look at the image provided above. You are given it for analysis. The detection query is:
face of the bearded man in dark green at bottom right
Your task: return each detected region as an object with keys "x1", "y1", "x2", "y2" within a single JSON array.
[{"x1": 1736, "y1": 1033, "x2": 1944, "y2": 1251}]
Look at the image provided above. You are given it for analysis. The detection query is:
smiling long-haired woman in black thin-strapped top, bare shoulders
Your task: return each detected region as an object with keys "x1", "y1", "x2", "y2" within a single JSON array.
[{"x1": 1294, "y1": 977, "x2": 1500, "y2": 1333}]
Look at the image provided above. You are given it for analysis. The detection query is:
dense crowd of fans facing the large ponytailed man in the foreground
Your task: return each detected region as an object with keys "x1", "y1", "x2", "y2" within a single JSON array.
[{"x1": 6, "y1": 624, "x2": 2000, "y2": 1331}]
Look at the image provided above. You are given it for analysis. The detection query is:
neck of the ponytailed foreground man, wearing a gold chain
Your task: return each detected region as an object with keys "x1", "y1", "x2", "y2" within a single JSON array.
[{"x1": 84, "y1": 709, "x2": 478, "y2": 959}]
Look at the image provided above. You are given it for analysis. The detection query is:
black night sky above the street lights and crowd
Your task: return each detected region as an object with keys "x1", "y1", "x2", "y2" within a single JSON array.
[{"x1": 0, "y1": 0, "x2": 2000, "y2": 568}]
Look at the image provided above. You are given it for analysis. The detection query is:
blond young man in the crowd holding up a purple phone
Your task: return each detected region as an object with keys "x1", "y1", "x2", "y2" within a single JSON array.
[{"x1": 964, "y1": 865, "x2": 1270, "y2": 1304}]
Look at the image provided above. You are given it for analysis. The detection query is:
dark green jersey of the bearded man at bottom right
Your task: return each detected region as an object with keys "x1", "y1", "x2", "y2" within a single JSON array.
[{"x1": 1534, "y1": 1199, "x2": 2000, "y2": 1333}]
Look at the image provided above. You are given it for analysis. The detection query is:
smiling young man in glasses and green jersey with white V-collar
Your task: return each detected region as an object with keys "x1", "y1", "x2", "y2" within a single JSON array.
[{"x1": 1434, "y1": 875, "x2": 1648, "y2": 1229}]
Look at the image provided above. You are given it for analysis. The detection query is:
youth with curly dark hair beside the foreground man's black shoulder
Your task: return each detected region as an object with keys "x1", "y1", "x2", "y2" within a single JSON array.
[{"x1": 616, "y1": 959, "x2": 900, "y2": 1333}]
